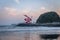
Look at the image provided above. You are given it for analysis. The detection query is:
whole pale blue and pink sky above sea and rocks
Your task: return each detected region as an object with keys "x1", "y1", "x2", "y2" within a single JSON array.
[{"x1": 0, "y1": 0, "x2": 60, "y2": 25}]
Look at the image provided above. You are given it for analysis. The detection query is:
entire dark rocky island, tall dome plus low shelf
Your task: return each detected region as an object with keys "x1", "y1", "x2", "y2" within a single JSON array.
[{"x1": 16, "y1": 11, "x2": 60, "y2": 27}]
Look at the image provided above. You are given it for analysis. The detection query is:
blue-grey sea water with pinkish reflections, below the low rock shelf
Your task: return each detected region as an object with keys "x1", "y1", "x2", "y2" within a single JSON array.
[{"x1": 0, "y1": 25, "x2": 60, "y2": 40}]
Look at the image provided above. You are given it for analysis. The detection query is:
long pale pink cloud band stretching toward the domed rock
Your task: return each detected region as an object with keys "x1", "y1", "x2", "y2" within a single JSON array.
[{"x1": 5, "y1": 7, "x2": 49, "y2": 18}]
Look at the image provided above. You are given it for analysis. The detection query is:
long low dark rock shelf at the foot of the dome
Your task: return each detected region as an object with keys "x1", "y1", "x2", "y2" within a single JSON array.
[{"x1": 16, "y1": 23, "x2": 60, "y2": 27}]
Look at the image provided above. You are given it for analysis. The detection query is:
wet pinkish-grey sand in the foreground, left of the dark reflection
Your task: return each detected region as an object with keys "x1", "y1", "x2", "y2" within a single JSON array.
[{"x1": 0, "y1": 32, "x2": 60, "y2": 40}]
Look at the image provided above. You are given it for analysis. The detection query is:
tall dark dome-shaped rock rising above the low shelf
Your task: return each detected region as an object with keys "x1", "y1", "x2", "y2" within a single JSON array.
[{"x1": 36, "y1": 12, "x2": 60, "y2": 23}]
